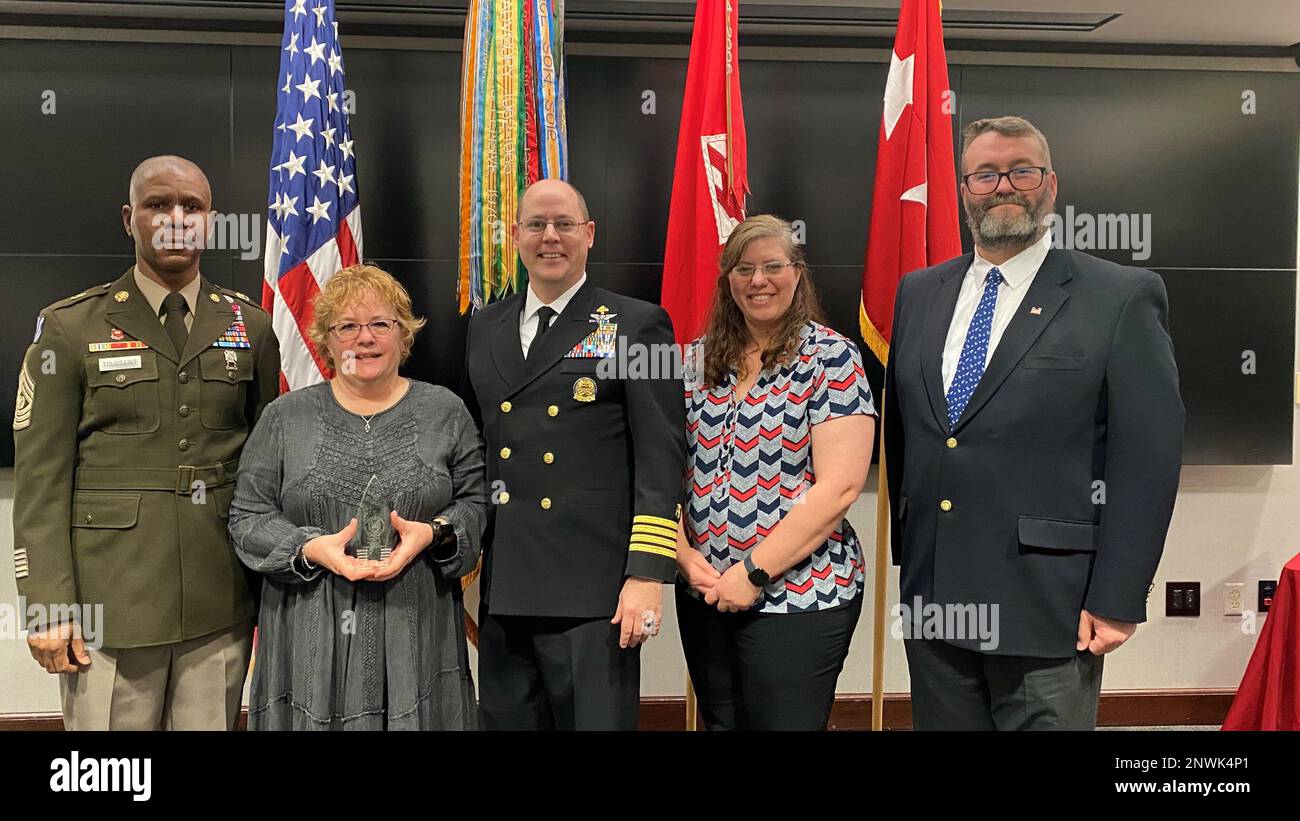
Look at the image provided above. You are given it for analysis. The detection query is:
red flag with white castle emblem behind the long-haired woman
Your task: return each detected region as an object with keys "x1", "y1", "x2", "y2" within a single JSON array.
[{"x1": 659, "y1": 0, "x2": 749, "y2": 343}]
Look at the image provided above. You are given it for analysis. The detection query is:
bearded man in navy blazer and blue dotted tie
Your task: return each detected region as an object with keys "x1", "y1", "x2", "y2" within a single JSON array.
[{"x1": 883, "y1": 117, "x2": 1183, "y2": 730}]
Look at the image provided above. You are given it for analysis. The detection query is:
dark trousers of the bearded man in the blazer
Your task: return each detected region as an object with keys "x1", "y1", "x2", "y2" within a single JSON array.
[{"x1": 904, "y1": 639, "x2": 1105, "y2": 730}]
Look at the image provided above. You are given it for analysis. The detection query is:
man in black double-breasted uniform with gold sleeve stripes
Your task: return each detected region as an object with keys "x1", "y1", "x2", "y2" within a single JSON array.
[{"x1": 467, "y1": 179, "x2": 686, "y2": 730}]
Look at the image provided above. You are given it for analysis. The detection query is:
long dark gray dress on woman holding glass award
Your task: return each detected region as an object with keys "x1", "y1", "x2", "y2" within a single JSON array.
[{"x1": 230, "y1": 379, "x2": 488, "y2": 730}]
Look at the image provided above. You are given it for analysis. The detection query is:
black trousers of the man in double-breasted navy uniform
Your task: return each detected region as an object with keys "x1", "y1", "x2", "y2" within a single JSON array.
[{"x1": 478, "y1": 608, "x2": 641, "y2": 730}]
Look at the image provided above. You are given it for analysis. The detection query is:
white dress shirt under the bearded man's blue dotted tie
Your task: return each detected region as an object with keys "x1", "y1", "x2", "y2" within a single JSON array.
[{"x1": 943, "y1": 231, "x2": 1052, "y2": 394}]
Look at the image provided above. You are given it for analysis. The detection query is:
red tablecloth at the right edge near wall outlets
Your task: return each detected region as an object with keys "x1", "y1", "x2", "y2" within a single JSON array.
[{"x1": 1223, "y1": 553, "x2": 1300, "y2": 730}]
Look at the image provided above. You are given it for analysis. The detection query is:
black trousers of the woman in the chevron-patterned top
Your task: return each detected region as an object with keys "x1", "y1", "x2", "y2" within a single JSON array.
[{"x1": 677, "y1": 582, "x2": 862, "y2": 730}]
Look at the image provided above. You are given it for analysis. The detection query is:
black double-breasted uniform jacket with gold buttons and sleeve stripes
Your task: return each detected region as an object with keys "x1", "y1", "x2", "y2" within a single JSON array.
[{"x1": 467, "y1": 278, "x2": 686, "y2": 618}]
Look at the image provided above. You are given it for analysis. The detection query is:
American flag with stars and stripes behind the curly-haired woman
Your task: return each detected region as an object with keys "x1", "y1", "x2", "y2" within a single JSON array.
[{"x1": 261, "y1": 0, "x2": 361, "y2": 390}]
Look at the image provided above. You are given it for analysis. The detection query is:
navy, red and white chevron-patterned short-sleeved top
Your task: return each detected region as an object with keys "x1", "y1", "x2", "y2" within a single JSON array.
[{"x1": 684, "y1": 322, "x2": 876, "y2": 613}]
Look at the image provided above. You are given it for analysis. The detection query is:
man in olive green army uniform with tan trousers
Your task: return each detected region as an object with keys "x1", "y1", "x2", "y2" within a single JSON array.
[{"x1": 13, "y1": 157, "x2": 280, "y2": 729}]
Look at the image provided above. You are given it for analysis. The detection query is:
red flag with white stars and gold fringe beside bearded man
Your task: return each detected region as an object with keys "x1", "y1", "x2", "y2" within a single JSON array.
[{"x1": 859, "y1": 0, "x2": 962, "y2": 362}]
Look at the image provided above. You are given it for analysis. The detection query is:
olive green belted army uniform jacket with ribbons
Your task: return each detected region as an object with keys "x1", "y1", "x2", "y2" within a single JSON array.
[{"x1": 13, "y1": 269, "x2": 280, "y2": 648}]
